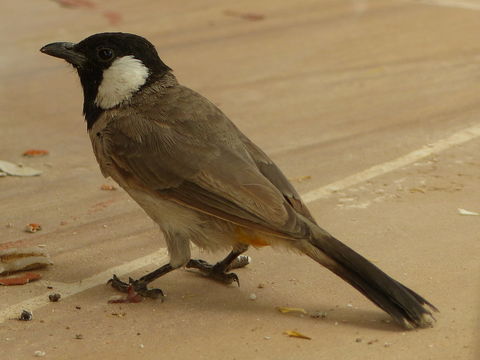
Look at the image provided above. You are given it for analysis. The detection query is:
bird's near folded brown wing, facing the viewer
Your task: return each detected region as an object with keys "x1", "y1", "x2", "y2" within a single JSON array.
[{"x1": 103, "y1": 90, "x2": 310, "y2": 238}]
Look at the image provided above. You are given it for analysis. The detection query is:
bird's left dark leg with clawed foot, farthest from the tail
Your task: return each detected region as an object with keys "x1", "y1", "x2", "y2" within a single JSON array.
[{"x1": 108, "y1": 264, "x2": 176, "y2": 299}]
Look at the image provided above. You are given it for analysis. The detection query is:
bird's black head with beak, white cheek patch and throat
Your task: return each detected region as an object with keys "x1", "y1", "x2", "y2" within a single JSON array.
[{"x1": 40, "y1": 33, "x2": 171, "y2": 128}]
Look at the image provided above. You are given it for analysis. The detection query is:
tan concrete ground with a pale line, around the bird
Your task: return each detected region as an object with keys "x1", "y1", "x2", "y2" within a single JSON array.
[{"x1": 0, "y1": 0, "x2": 480, "y2": 360}]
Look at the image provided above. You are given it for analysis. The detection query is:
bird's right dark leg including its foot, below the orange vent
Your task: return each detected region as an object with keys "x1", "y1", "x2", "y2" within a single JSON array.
[{"x1": 186, "y1": 245, "x2": 250, "y2": 286}]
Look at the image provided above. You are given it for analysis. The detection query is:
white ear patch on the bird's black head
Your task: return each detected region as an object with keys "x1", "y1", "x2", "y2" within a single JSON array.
[{"x1": 95, "y1": 55, "x2": 149, "y2": 110}]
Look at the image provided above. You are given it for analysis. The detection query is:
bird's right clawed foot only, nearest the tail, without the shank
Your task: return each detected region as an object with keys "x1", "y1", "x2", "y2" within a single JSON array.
[{"x1": 186, "y1": 256, "x2": 250, "y2": 286}]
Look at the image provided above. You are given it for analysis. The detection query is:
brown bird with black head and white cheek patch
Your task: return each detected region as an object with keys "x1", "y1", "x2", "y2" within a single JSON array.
[{"x1": 40, "y1": 32, "x2": 438, "y2": 329}]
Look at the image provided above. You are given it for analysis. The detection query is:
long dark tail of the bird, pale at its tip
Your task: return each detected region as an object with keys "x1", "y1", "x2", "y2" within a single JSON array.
[{"x1": 299, "y1": 226, "x2": 438, "y2": 329}]
